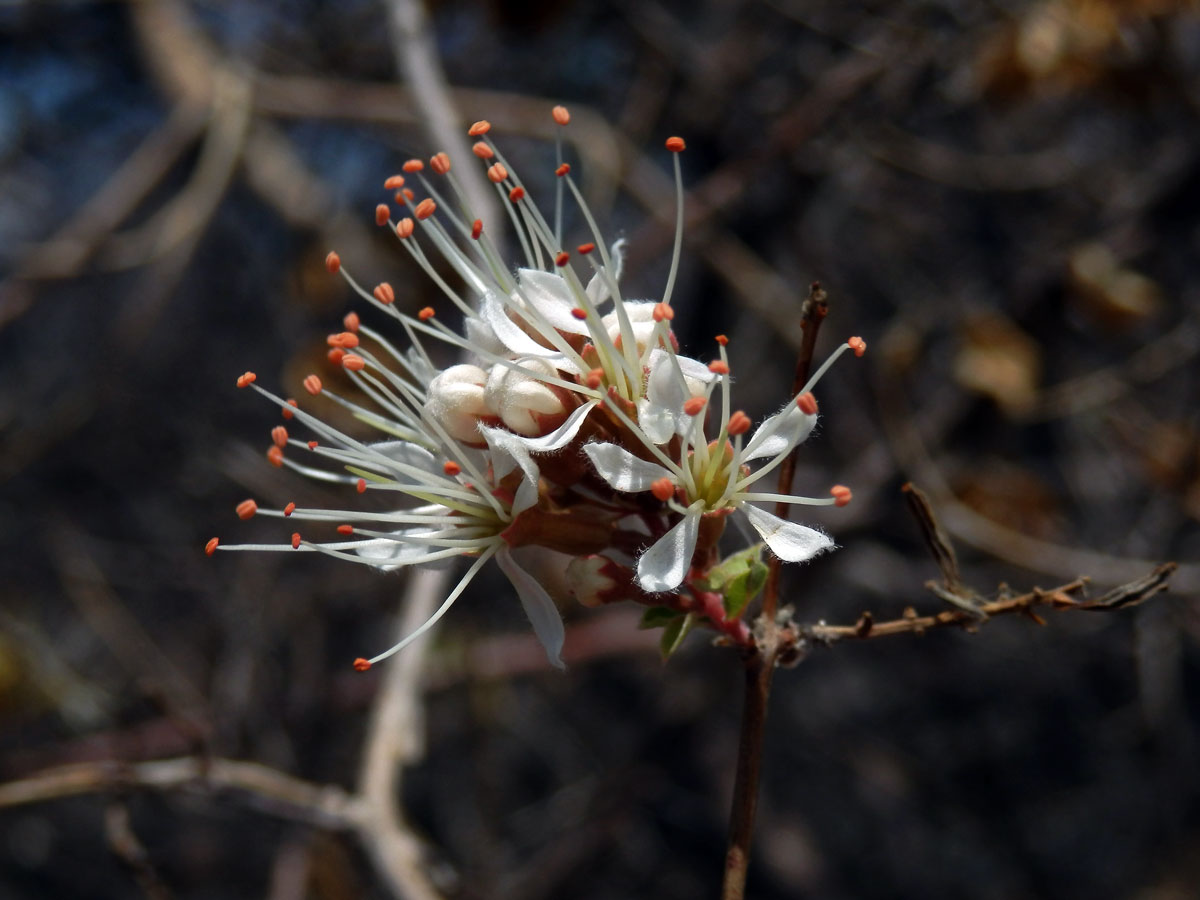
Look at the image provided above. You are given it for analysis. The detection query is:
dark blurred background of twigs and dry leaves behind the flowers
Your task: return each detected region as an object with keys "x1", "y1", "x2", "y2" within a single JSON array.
[{"x1": 0, "y1": 0, "x2": 1200, "y2": 900}]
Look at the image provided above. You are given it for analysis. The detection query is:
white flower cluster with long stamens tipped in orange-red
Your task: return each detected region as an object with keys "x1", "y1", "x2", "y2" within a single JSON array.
[{"x1": 206, "y1": 107, "x2": 865, "y2": 670}]
